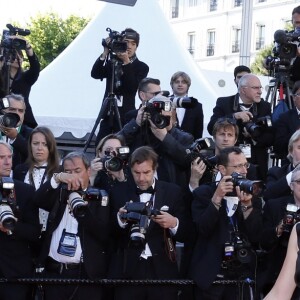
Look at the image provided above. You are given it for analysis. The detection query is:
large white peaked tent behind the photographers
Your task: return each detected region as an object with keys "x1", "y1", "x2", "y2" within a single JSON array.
[{"x1": 30, "y1": 0, "x2": 270, "y2": 137}]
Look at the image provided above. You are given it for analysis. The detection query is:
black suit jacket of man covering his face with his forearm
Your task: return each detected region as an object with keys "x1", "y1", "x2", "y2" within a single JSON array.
[{"x1": 35, "y1": 181, "x2": 110, "y2": 279}]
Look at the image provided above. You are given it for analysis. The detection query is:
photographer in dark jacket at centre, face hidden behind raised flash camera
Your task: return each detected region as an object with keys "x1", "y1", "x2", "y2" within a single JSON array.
[{"x1": 118, "y1": 95, "x2": 193, "y2": 187}]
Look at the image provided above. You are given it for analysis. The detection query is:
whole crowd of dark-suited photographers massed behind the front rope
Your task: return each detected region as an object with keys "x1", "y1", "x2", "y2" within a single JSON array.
[{"x1": 0, "y1": 7, "x2": 300, "y2": 300}]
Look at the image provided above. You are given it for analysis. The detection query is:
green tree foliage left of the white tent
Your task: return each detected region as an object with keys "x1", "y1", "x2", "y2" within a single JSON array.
[{"x1": 19, "y1": 12, "x2": 90, "y2": 69}]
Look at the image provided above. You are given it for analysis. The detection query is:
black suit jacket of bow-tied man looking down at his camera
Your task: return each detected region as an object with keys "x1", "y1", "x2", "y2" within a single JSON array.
[{"x1": 110, "y1": 180, "x2": 191, "y2": 279}]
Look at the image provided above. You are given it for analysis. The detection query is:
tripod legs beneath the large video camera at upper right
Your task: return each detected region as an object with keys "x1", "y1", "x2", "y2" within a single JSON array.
[{"x1": 266, "y1": 71, "x2": 293, "y2": 111}]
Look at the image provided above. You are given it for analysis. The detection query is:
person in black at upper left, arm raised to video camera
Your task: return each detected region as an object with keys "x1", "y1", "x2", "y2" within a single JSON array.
[{"x1": 0, "y1": 28, "x2": 40, "y2": 128}]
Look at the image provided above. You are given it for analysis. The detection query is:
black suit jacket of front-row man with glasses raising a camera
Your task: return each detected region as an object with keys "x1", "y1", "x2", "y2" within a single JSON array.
[{"x1": 190, "y1": 184, "x2": 262, "y2": 290}]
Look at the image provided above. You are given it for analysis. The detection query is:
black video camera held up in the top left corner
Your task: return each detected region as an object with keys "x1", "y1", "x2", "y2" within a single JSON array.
[{"x1": 1, "y1": 24, "x2": 30, "y2": 51}]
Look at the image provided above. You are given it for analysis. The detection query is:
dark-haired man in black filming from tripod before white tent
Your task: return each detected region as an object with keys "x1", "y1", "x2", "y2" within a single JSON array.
[{"x1": 91, "y1": 28, "x2": 149, "y2": 142}]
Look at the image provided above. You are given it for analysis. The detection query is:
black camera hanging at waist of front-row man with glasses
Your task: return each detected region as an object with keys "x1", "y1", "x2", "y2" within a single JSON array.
[{"x1": 223, "y1": 232, "x2": 252, "y2": 268}]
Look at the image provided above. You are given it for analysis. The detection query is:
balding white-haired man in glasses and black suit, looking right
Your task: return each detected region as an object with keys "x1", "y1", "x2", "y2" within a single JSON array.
[{"x1": 207, "y1": 74, "x2": 273, "y2": 180}]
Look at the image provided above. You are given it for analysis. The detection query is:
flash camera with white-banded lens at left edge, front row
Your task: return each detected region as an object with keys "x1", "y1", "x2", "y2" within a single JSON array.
[{"x1": 0, "y1": 177, "x2": 17, "y2": 231}]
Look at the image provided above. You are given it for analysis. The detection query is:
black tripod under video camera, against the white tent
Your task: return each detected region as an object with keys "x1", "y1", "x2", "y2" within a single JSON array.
[{"x1": 83, "y1": 51, "x2": 122, "y2": 152}]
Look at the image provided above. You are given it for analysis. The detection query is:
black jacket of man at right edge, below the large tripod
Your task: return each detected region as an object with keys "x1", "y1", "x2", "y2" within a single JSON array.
[{"x1": 274, "y1": 107, "x2": 300, "y2": 158}]
